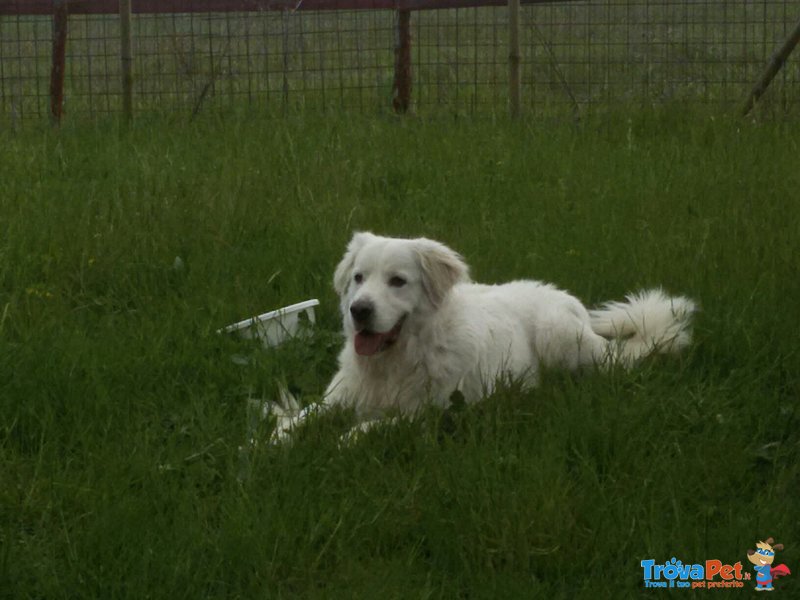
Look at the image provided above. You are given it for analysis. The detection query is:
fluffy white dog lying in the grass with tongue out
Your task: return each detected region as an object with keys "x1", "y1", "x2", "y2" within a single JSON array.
[{"x1": 276, "y1": 233, "x2": 696, "y2": 438}]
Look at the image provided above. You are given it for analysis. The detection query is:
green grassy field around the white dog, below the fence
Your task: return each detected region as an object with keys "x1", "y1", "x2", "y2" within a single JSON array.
[{"x1": 0, "y1": 109, "x2": 800, "y2": 599}]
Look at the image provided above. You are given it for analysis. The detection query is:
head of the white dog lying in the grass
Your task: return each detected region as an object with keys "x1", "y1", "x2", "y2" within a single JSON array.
[{"x1": 333, "y1": 233, "x2": 469, "y2": 356}]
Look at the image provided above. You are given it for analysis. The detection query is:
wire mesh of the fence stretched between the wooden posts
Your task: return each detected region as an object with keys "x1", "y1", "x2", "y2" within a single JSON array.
[{"x1": 0, "y1": 0, "x2": 800, "y2": 120}]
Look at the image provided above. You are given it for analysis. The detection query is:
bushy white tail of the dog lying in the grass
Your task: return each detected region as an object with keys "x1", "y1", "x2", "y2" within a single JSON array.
[{"x1": 589, "y1": 289, "x2": 697, "y2": 366}]
